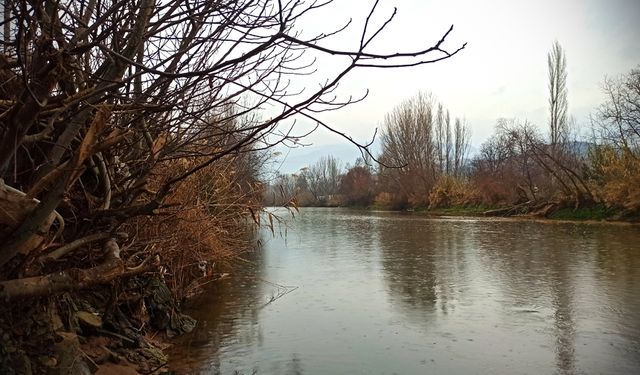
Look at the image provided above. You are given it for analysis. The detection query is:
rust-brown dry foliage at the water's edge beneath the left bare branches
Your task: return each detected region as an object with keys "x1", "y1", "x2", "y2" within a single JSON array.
[{"x1": 128, "y1": 156, "x2": 263, "y2": 297}]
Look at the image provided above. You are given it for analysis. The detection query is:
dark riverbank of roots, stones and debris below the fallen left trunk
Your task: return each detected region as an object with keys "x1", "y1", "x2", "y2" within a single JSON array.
[{"x1": 0, "y1": 275, "x2": 196, "y2": 375}]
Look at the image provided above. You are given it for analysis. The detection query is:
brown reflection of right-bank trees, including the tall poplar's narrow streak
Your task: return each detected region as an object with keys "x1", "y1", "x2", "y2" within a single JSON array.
[{"x1": 475, "y1": 221, "x2": 640, "y2": 374}]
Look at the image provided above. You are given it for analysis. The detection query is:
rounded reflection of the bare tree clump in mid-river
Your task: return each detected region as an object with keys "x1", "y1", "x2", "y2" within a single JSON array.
[{"x1": 378, "y1": 217, "x2": 467, "y2": 322}]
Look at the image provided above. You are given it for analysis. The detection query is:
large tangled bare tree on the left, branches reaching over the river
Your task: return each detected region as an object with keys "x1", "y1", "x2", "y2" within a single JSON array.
[{"x1": 0, "y1": 0, "x2": 464, "y2": 295}]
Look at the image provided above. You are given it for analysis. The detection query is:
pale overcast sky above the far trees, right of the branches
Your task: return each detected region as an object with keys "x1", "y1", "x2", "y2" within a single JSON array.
[{"x1": 268, "y1": 0, "x2": 640, "y2": 172}]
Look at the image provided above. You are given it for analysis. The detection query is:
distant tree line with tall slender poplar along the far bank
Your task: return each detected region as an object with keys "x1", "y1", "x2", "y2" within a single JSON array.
[{"x1": 267, "y1": 41, "x2": 640, "y2": 217}]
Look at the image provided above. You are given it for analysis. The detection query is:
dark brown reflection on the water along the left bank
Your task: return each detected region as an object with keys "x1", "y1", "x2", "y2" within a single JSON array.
[{"x1": 169, "y1": 214, "x2": 316, "y2": 375}]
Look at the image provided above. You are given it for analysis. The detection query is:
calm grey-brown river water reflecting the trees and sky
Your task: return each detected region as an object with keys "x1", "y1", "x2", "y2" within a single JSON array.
[{"x1": 172, "y1": 209, "x2": 640, "y2": 374}]
